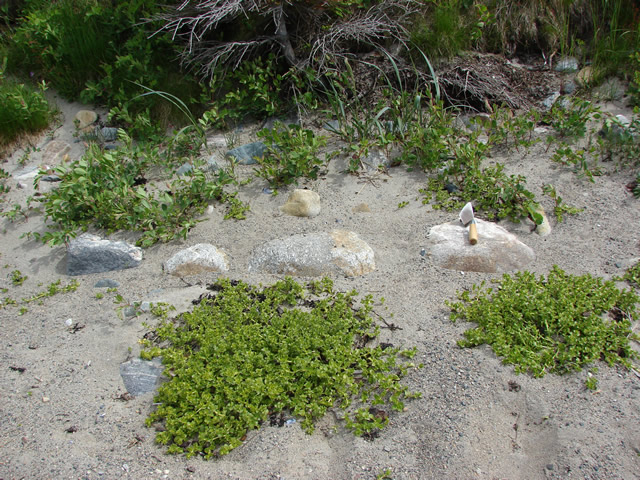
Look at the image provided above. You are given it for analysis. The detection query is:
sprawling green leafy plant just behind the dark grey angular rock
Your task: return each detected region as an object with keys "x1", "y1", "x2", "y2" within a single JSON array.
[{"x1": 33, "y1": 130, "x2": 249, "y2": 247}]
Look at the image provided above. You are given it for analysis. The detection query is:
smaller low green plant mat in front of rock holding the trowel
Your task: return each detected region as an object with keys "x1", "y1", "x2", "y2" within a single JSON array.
[{"x1": 447, "y1": 266, "x2": 640, "y2": 377}]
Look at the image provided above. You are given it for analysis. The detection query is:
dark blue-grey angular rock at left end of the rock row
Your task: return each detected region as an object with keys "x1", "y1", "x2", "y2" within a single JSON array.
[{"x1": 67, "y1": 233, "x2": 142, "y2": 275}]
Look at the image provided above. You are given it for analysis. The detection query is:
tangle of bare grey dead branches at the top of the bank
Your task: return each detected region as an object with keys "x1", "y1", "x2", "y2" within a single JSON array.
[{"x1": 155, "y1": 0, "x2": 422, "y2": 77}]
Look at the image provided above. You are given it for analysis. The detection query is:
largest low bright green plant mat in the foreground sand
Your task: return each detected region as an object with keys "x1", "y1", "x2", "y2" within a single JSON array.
[{"x1": 142, "y1": 277, "x2": 417, "y2": 458}]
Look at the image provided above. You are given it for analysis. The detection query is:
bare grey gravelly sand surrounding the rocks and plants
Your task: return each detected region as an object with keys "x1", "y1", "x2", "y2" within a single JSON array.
[{"x1": 0, "y1": 86, "x2": 640, "y2": 480}]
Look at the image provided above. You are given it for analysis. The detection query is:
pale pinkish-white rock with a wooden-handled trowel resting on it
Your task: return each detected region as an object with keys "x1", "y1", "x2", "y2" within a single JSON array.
[{"x1": 429, "y1": 219, "x2": 535, "y2": 273}]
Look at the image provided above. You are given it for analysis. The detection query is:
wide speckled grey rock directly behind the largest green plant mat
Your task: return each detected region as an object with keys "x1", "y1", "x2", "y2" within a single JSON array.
[{"x1": 249, "y1": 230, "x2": 376, "y2": 277}]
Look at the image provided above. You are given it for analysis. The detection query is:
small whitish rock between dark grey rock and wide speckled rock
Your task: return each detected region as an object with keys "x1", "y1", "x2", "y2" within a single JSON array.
[{"x1": 164, "y1": 243, "x2": 229, "y2": 277}]
